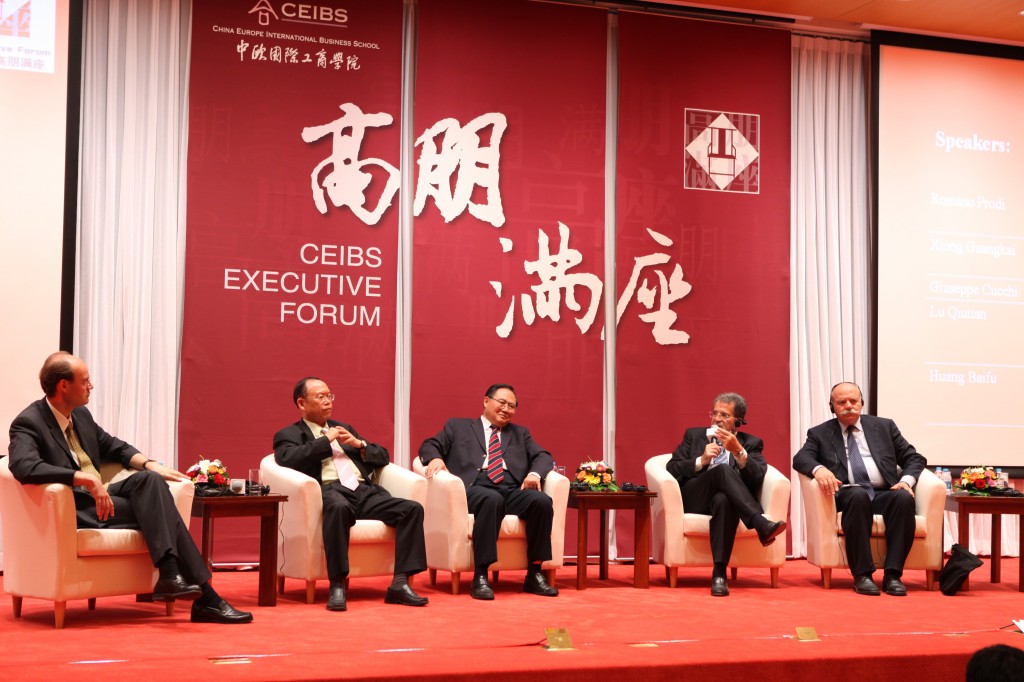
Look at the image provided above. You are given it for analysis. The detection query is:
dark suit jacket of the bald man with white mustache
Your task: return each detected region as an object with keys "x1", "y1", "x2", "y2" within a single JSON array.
[{"x1": 793, "y1": 415, "x2": 928, "y2": 487}]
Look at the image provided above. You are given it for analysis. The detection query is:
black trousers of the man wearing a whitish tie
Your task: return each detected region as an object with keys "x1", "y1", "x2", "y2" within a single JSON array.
[{"x1": 323, "y1": 481, "x2": 427, "y2": 582}]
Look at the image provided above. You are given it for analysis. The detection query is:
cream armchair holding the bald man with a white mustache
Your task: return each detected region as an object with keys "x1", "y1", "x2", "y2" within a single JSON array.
[{"x1": 798, "y1": 469, "x2": 946, "y2": 590}]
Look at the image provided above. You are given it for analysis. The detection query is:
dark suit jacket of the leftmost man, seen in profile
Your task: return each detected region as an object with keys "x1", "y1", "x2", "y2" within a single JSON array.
[{"x1": 7, "y1": 398, "x2": 138, "y2": 485}]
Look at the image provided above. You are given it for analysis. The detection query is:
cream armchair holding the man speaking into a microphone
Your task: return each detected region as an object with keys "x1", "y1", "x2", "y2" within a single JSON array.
[{"x1": 644, "y1": 455, "x2": 791, "y2": 588}]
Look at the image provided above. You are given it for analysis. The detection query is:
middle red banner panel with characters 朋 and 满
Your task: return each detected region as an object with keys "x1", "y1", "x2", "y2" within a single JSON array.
[{"x1": 411, "y1": 0, "x2": 606, "y2": 466}]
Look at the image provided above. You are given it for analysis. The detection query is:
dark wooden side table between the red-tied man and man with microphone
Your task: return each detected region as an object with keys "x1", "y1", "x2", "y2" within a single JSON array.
[{"x1": 568, "y1": 489, "x2": 657, "y2": 590}]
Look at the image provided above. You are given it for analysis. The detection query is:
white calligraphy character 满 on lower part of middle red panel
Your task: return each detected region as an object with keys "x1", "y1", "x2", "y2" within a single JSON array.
[{"x1": 490, "y1": 222, "x2": 604, "y2": 339}]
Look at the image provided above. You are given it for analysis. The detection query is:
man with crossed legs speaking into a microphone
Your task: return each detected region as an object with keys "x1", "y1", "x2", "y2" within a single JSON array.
[{"x1": 668, "y1": 393, "x2": 785, "y2": 597}]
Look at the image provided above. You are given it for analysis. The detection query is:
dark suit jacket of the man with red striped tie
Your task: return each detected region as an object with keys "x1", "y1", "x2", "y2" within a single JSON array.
[{"x1": 420, "y1": 417, "x2": 554, "y2": 487}]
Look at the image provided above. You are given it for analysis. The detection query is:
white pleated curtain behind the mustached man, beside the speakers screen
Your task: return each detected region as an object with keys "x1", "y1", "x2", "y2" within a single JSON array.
[{"x1": 790, "y1": 35, "x2": 873, "y2": 556}]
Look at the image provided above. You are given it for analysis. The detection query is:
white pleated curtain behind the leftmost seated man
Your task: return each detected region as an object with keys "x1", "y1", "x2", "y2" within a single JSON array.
[{"x1": 74, "y1": 0, "x2": 190, "y2": 465}]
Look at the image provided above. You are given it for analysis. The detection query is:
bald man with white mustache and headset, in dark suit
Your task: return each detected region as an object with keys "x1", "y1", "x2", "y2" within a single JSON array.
[{"x1": 793, "y1": 382, "x2": 928, "y2": 597}]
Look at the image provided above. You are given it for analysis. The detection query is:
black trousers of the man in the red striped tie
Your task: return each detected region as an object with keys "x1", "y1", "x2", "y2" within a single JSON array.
[{"x1": 466, "y1": 471, "x2": 554, "y2": 570}]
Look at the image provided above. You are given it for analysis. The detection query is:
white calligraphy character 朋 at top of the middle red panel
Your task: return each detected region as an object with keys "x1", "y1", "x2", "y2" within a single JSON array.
[{"x1": 413, "y1": 114, "x2": 508, "y2": 227}]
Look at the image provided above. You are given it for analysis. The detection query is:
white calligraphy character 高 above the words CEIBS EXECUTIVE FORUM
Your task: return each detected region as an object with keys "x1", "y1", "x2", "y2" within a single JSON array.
[{"x1": 302, "y1": 102, "x2": 399, "y2": 225}]
